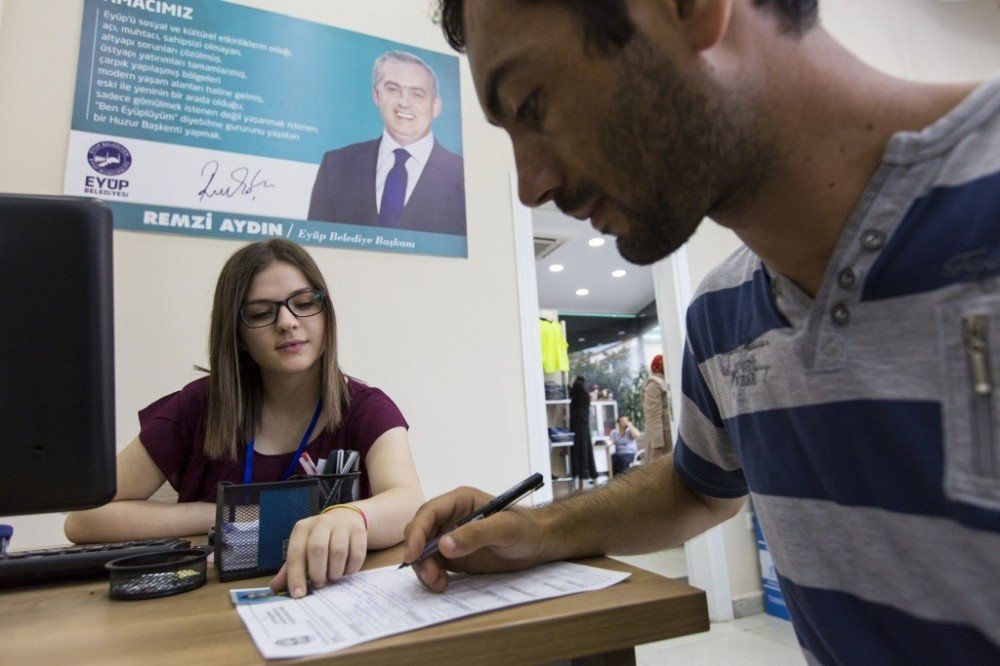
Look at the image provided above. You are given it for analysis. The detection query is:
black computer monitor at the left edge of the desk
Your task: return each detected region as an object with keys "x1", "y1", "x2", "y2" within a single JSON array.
[{"x1": 0, "y1": 194, "x2": 115, "y2": 516}]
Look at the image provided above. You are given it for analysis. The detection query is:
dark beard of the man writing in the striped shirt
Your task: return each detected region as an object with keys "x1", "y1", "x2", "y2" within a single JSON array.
[{"x1": 556, "y1": 33, "x2": 772, "y2": 264}]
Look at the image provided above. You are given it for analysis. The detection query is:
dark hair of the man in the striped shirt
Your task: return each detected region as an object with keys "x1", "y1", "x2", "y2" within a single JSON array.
[{"x1": 436, "y1": 0, "x2": 819, "y2": 53}]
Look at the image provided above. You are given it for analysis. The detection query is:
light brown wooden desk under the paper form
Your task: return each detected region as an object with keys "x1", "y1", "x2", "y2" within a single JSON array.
[{"x1": 0, "y1": 546, "x2": 708, "y2": 665}]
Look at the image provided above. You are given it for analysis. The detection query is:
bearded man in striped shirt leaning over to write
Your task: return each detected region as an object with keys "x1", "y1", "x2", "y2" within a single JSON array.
[{"x1": 405, "y1": 0, "x2": 1000, "y2": 663}]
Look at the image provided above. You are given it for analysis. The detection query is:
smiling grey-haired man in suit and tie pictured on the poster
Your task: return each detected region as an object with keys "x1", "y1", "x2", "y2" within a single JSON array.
[{"x1": 309, "y1": 51, "x2": 465, "y2": 236}]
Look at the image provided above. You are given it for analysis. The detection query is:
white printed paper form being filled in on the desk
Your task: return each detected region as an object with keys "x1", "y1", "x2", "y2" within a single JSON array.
[{"x1": 236, "y1": 562, "x2": 629, "y2": 659}]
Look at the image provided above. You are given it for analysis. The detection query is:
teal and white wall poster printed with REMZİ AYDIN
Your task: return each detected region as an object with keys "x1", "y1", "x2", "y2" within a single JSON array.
[{"x1": 64, "y1": 0, "x2": 468, "y2": 257}]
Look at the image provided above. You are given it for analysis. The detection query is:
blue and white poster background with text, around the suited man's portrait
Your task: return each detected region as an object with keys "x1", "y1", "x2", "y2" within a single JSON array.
[{"x1": 64, "y1": 0, "x2": 467, "y2": 257}]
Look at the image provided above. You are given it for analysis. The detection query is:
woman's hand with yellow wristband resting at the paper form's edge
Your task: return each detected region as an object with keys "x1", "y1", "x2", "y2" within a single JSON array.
[{"x1": 271, "y1": 507, "x2": 368, "y2": 599}]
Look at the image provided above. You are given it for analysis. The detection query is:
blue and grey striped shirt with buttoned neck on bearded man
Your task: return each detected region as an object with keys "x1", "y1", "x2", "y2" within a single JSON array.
[{"x1": 674, "y1": 77, "x2": 1000, "y2": 664}]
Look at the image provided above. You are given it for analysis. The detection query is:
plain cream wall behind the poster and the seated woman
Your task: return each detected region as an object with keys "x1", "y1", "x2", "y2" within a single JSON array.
[{"x1": 0, "y1": 0, "x2": 529, "y2": 548}]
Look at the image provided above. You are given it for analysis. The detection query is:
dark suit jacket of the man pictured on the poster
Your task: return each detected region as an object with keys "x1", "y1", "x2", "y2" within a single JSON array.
[{"x1": 309, "y1": 139, "x2": 465, "y2": 236}]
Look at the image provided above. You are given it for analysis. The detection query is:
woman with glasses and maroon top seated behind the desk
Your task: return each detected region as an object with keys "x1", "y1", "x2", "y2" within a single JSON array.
[{"x1": 65, "y1": 239, "x2": 423, "y2": 597}]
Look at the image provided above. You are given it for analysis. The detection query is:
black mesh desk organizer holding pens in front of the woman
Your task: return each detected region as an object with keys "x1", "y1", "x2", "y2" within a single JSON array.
[{"x1": 214, "y1": 472, "x2": 361, "y2": 581}]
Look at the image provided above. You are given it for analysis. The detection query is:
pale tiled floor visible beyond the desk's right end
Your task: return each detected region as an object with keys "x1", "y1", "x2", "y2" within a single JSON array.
[{"x1": 616, "y1": 548, "x2": 806, "y2": 666}]
